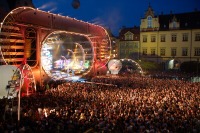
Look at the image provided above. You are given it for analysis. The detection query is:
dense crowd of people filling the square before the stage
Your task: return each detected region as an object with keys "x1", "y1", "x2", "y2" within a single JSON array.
[{"x1": 0, "y1": 72, "x2": 200, "y2": 133}]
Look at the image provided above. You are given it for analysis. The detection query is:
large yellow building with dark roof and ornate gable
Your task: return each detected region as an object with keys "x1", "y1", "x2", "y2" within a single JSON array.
[{"x1": 140, "y1": 6, "x2": 200, "y2": 69}]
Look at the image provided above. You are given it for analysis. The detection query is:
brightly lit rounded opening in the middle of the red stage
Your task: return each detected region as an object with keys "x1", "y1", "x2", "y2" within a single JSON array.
[{"x1": 41, "y1": 31, "x2": 93, "y2": 80}]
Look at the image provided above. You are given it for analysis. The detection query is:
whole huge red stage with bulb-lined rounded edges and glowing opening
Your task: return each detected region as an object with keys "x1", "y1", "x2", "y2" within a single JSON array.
[{"x1": 0, "y1": 7, "x2": 111, "y2": 83}]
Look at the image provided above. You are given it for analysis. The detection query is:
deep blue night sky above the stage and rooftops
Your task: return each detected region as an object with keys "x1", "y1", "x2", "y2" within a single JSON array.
[{"x1": 33, "y1": 0, "x2": 200, "y2": 36}]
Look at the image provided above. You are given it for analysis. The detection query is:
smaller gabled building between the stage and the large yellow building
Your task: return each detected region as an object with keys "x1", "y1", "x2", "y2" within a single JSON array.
[{"x1": 118, "y1": 26, "x2": 140, "y2": 60}]
